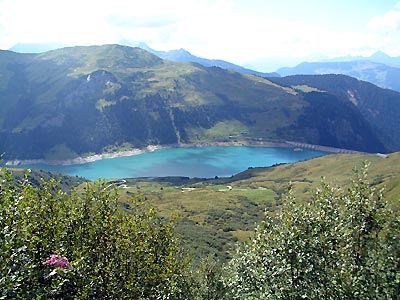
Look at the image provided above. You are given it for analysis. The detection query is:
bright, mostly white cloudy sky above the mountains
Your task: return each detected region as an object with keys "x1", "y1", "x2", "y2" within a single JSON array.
[{"x1": 0, "y1": 0, "x2": 400, "y2": 71}]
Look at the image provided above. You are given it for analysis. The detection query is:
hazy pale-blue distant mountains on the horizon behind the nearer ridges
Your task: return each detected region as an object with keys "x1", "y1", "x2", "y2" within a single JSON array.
[{"x1": 9, "y1": 40, "x2": 400, "y2": 91}]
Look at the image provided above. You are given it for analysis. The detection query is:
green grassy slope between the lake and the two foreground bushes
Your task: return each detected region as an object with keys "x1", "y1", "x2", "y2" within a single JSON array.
[{"x1": 111, "y1": 153, "x2": 400, "y2": 259}]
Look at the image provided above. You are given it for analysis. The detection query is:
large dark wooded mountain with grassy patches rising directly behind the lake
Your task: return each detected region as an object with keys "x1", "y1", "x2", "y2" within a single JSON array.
[{"x1": 0, "y1": 45, "x2": 400, "y2": 159}]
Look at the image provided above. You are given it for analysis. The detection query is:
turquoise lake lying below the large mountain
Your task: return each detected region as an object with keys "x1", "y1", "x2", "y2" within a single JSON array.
[{"x1": 15, "y1": 146, "x2": 328, "y2": 180}]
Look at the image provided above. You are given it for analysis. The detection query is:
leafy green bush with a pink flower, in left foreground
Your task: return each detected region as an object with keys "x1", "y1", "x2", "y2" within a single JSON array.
[{"x1": 0, "y1": 170, "x2": 187, "y2": 299}]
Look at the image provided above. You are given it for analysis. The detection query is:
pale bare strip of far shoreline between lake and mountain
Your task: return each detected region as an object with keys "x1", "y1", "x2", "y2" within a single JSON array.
[{"x1": 5, "y1": 141, "x2": 364, "y2": 166}]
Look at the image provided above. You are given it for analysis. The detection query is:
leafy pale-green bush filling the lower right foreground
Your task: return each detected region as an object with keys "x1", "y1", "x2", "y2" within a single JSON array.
[{"x1": 225, "y1": 167, "x2": 400, "y2": 299}]
